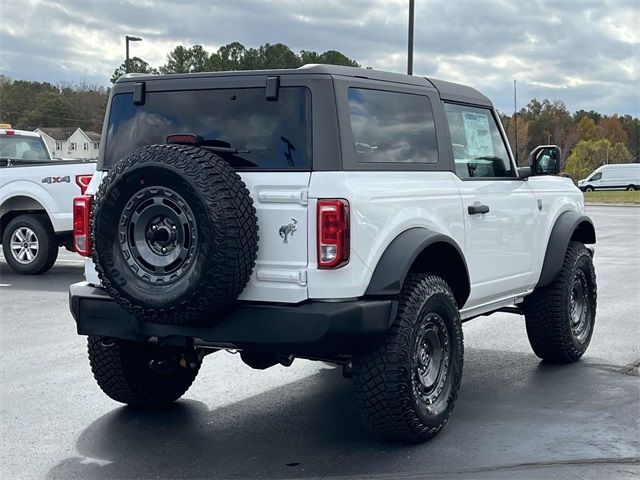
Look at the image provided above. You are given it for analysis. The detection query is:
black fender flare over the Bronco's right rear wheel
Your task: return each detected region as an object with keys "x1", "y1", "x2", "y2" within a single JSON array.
[{"x1": 365, "y1": 227, "x2": 470, "y2": 303}]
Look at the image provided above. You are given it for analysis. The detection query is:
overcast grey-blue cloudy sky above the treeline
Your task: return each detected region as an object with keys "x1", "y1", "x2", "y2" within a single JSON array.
[{"x1": 0, "y1": 0, "x2": 640, "y2": 116}]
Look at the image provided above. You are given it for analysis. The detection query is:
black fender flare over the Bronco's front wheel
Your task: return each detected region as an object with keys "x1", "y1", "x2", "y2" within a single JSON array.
[{"x1": 536, "y1": 211, "x2": 596, "y2": 288}]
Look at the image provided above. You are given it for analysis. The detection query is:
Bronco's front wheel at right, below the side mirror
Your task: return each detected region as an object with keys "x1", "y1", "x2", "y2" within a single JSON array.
[{"x1": 522, "y1": 242, "x2": 597, "y2": 363}]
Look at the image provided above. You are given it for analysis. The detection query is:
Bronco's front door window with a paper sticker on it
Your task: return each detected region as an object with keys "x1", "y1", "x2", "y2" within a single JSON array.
[{"x1": 444, "y1": 103, "x2": 516, "y2": 179}]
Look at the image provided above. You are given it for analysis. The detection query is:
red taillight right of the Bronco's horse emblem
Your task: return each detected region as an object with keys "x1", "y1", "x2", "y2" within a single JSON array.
[{"x1": 317, "y1": 199, "x2": 349, "y2": 268}]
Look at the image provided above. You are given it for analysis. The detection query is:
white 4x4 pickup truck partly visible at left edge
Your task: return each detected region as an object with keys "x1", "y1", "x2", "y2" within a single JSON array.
[{"x1": 0, "y1": 125, "x2": 95, "y2": 275}]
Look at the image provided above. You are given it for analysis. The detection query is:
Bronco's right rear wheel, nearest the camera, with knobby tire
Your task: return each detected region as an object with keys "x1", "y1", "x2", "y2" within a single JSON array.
[{"x1": 353, "y1": 274, "x2": 464, "y2": 442}]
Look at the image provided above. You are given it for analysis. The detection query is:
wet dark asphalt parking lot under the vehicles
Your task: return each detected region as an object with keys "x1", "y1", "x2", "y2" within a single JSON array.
[{"x1": 0, "y1": 207, "x2": 640, "y2": 479}]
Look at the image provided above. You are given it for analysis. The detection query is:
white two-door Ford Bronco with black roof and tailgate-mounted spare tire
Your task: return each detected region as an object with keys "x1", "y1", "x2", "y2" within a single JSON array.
[{"x1": 70, "y1": 65, "x2": 596, "y2": 442}]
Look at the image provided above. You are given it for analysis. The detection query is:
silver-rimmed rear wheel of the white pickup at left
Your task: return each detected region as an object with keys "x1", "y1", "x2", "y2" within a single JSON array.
[{"x1": 2, "y1": 214, "x2": 58, "y2": 275}]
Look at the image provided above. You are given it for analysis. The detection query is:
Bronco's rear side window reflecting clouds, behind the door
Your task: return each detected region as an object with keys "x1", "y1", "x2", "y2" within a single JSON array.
[{"x1": 349, "y1": 87, "x2": 438, "y2": 163}]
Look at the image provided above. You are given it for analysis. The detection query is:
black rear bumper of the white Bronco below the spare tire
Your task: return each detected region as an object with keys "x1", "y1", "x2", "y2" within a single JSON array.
[{"x1": 69, "y1": 282, "x2": 397, "y2": 357}]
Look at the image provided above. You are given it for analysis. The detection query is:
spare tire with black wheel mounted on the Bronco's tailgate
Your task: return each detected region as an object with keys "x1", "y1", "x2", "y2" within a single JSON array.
[{"x1": 91, "y1": 145, "x2": 258, "y2": 325}]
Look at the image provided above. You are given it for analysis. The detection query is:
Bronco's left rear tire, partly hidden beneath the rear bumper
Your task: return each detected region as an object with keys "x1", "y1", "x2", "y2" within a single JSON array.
[{"x1": 88, "y1": 336, "x2": 202, "y2": 408}]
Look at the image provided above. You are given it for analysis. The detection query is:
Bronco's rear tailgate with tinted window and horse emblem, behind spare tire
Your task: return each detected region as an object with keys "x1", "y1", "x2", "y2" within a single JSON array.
[{"x1": 86, "y1": 75, "x2": 330, "y2": 303}]
